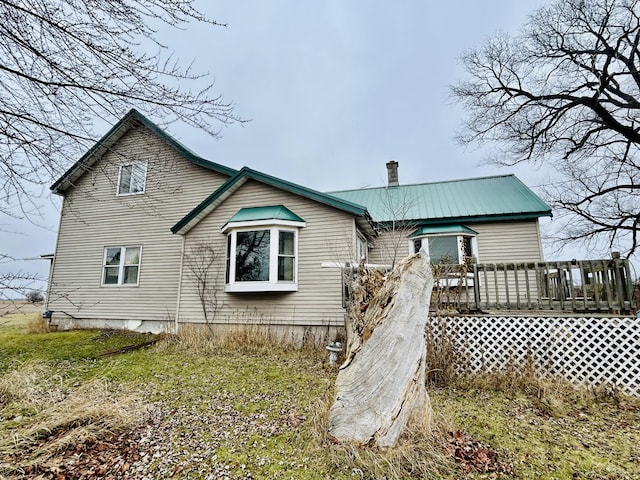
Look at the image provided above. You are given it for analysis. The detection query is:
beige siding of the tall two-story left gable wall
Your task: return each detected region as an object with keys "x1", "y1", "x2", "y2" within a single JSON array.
[{"x1": 47, "y1": 127, "x2": 232, "y2": 322}]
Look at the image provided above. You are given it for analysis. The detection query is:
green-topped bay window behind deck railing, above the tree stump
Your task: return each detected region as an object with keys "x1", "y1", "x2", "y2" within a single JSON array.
[{"x1": 411, "y1": 225, "x2": 477, "y2": 264}]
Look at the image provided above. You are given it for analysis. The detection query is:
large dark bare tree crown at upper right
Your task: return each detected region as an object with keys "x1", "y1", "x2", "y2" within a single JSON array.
[{"x1": 452, "y1": 0, "x2": 640, "y2": 254}]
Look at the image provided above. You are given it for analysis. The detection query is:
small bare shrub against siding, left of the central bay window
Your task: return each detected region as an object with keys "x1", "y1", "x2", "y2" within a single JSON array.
[{"x1": 185, "y1": 240, "x2": 223, "y2": 329}]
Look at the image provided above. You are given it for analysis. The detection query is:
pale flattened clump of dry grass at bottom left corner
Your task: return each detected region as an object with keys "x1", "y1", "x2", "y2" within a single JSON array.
[{"x1": 0, "y1": 363, "x2": 147, "y2": 474}]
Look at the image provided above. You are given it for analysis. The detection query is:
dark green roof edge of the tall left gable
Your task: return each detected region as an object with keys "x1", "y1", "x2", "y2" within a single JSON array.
[{"x1": 50, "y1": 108, "x2": 237, "y2": 194}]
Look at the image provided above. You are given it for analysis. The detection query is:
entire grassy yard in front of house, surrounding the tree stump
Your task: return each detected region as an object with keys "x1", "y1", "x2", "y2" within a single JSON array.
[{"x1": 0, "y1": 315, "x2": 640, "y2": 480}]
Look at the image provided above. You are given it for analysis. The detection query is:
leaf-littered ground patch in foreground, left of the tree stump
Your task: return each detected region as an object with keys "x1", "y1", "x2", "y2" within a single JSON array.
[{"x1": 11, "y1": 392, "x2": 306, "y2": 480}]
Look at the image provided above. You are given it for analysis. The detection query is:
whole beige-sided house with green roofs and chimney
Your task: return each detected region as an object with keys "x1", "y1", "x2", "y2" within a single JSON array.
[{"x1": 46, "y1": 110, "x2": 550, "y2": 337}]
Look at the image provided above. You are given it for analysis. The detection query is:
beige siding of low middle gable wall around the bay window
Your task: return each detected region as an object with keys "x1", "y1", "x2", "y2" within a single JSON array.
[{"x1": 179, "y1": 180, "x2": 355, "y2": 327}]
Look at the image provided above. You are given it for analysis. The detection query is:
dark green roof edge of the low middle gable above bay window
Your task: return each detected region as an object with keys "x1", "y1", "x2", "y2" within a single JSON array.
[{"x1": 171, "y1": 167, "x2": 373, "y2": 235}]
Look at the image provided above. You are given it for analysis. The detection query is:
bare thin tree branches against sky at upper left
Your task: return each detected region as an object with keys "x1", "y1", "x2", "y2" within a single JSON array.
[{"x1": 0, "y1": 0, "x2": 241, "y2": 298}]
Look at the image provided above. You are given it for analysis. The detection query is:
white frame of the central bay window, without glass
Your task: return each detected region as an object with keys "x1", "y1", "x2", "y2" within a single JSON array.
[{"x1": 222, "y1": 220, "x2": 306, "y2": 293}]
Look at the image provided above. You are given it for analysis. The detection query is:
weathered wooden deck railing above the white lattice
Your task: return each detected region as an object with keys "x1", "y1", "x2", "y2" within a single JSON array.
[{"x1": 343, "y1": 257, "x2": 640, "y2": 315}]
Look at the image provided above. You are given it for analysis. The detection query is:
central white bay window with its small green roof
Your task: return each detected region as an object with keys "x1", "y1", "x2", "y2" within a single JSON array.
[{"x1": 222, "y1": 205, "x2": 306, "y2": 292}]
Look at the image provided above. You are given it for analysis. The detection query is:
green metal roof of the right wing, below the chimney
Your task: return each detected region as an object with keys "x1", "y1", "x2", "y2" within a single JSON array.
[{"x1": 331, "y1": 175, "x2": 551, "y2": 225}]
